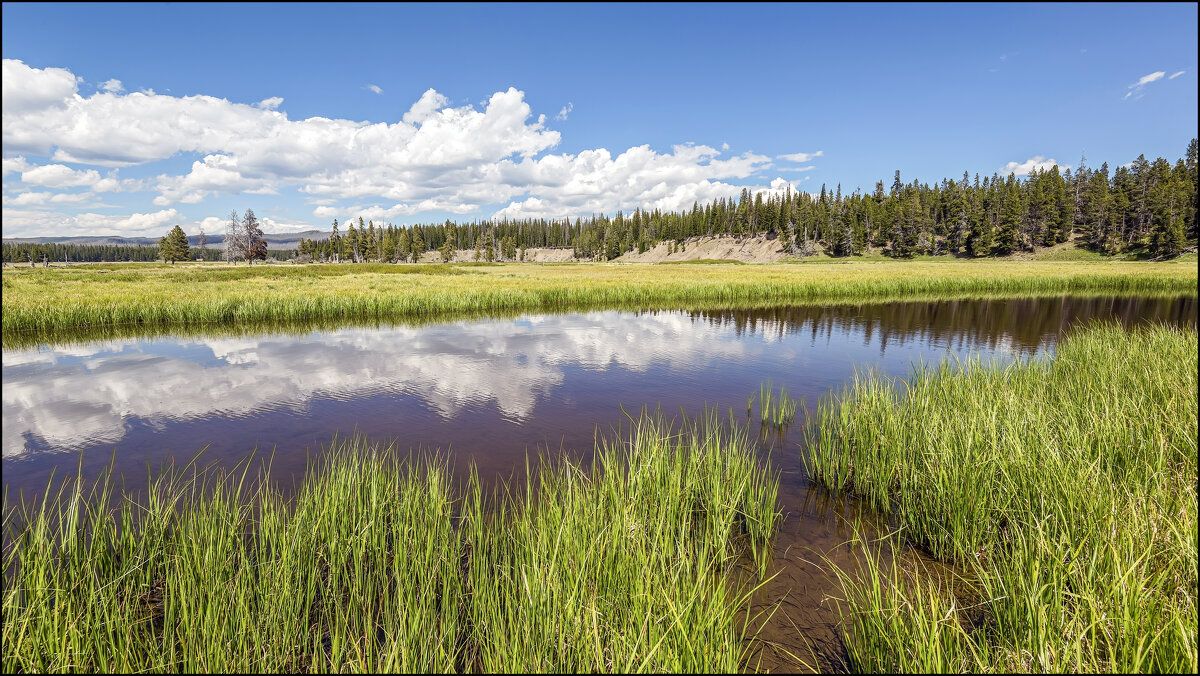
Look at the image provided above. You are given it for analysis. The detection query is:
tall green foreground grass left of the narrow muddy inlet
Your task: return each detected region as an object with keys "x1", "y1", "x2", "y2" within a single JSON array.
[{"x1": 4, "y1": 417, "x2": 778, "y2": 672}]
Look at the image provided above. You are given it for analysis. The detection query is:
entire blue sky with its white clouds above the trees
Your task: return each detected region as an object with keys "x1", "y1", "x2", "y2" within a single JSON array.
[{"x1": 2, "y1": 2, "x2": 1198, "y2": 237}]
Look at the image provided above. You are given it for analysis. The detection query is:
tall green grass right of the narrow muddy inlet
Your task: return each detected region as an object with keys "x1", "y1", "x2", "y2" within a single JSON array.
[{"x1": 808, "y1": 325, "x2": 1198, "y2": 672}]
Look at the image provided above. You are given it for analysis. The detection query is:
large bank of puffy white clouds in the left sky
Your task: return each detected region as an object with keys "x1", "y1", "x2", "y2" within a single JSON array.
[{"x1": 2, "y1": 59, "x2": 823, "y2": 234}]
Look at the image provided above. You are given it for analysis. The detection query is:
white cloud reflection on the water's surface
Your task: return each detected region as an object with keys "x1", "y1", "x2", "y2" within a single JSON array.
[{"x1": 4, "y1": 312, "x2": 751, "y2": 457}]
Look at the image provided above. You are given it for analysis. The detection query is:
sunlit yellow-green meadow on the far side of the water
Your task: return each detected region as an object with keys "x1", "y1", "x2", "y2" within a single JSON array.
[{"x1": 2, "y1": 261, "x2": 1196, "y2": 335}]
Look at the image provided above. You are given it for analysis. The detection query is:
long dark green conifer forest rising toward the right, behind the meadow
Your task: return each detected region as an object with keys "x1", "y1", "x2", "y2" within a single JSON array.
[{"x1": 298, "y1": 139, "x2": 1198, "y2": 262}]
